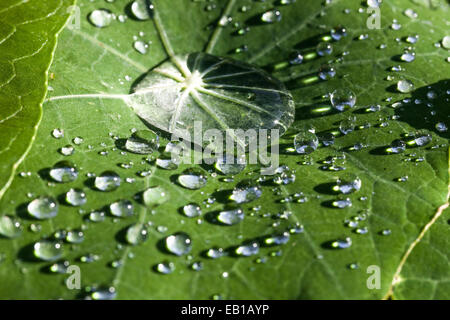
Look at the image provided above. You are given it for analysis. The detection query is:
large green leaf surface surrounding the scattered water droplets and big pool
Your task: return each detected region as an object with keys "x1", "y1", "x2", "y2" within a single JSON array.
[{"x1": 0, "y1": 0, "x2": 449, "y2": 299}]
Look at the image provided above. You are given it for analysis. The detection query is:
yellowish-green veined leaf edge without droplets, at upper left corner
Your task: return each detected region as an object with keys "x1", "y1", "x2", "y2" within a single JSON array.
[{"x1": 0, "y1": 0, "x2": 72, "y2": 198}]
